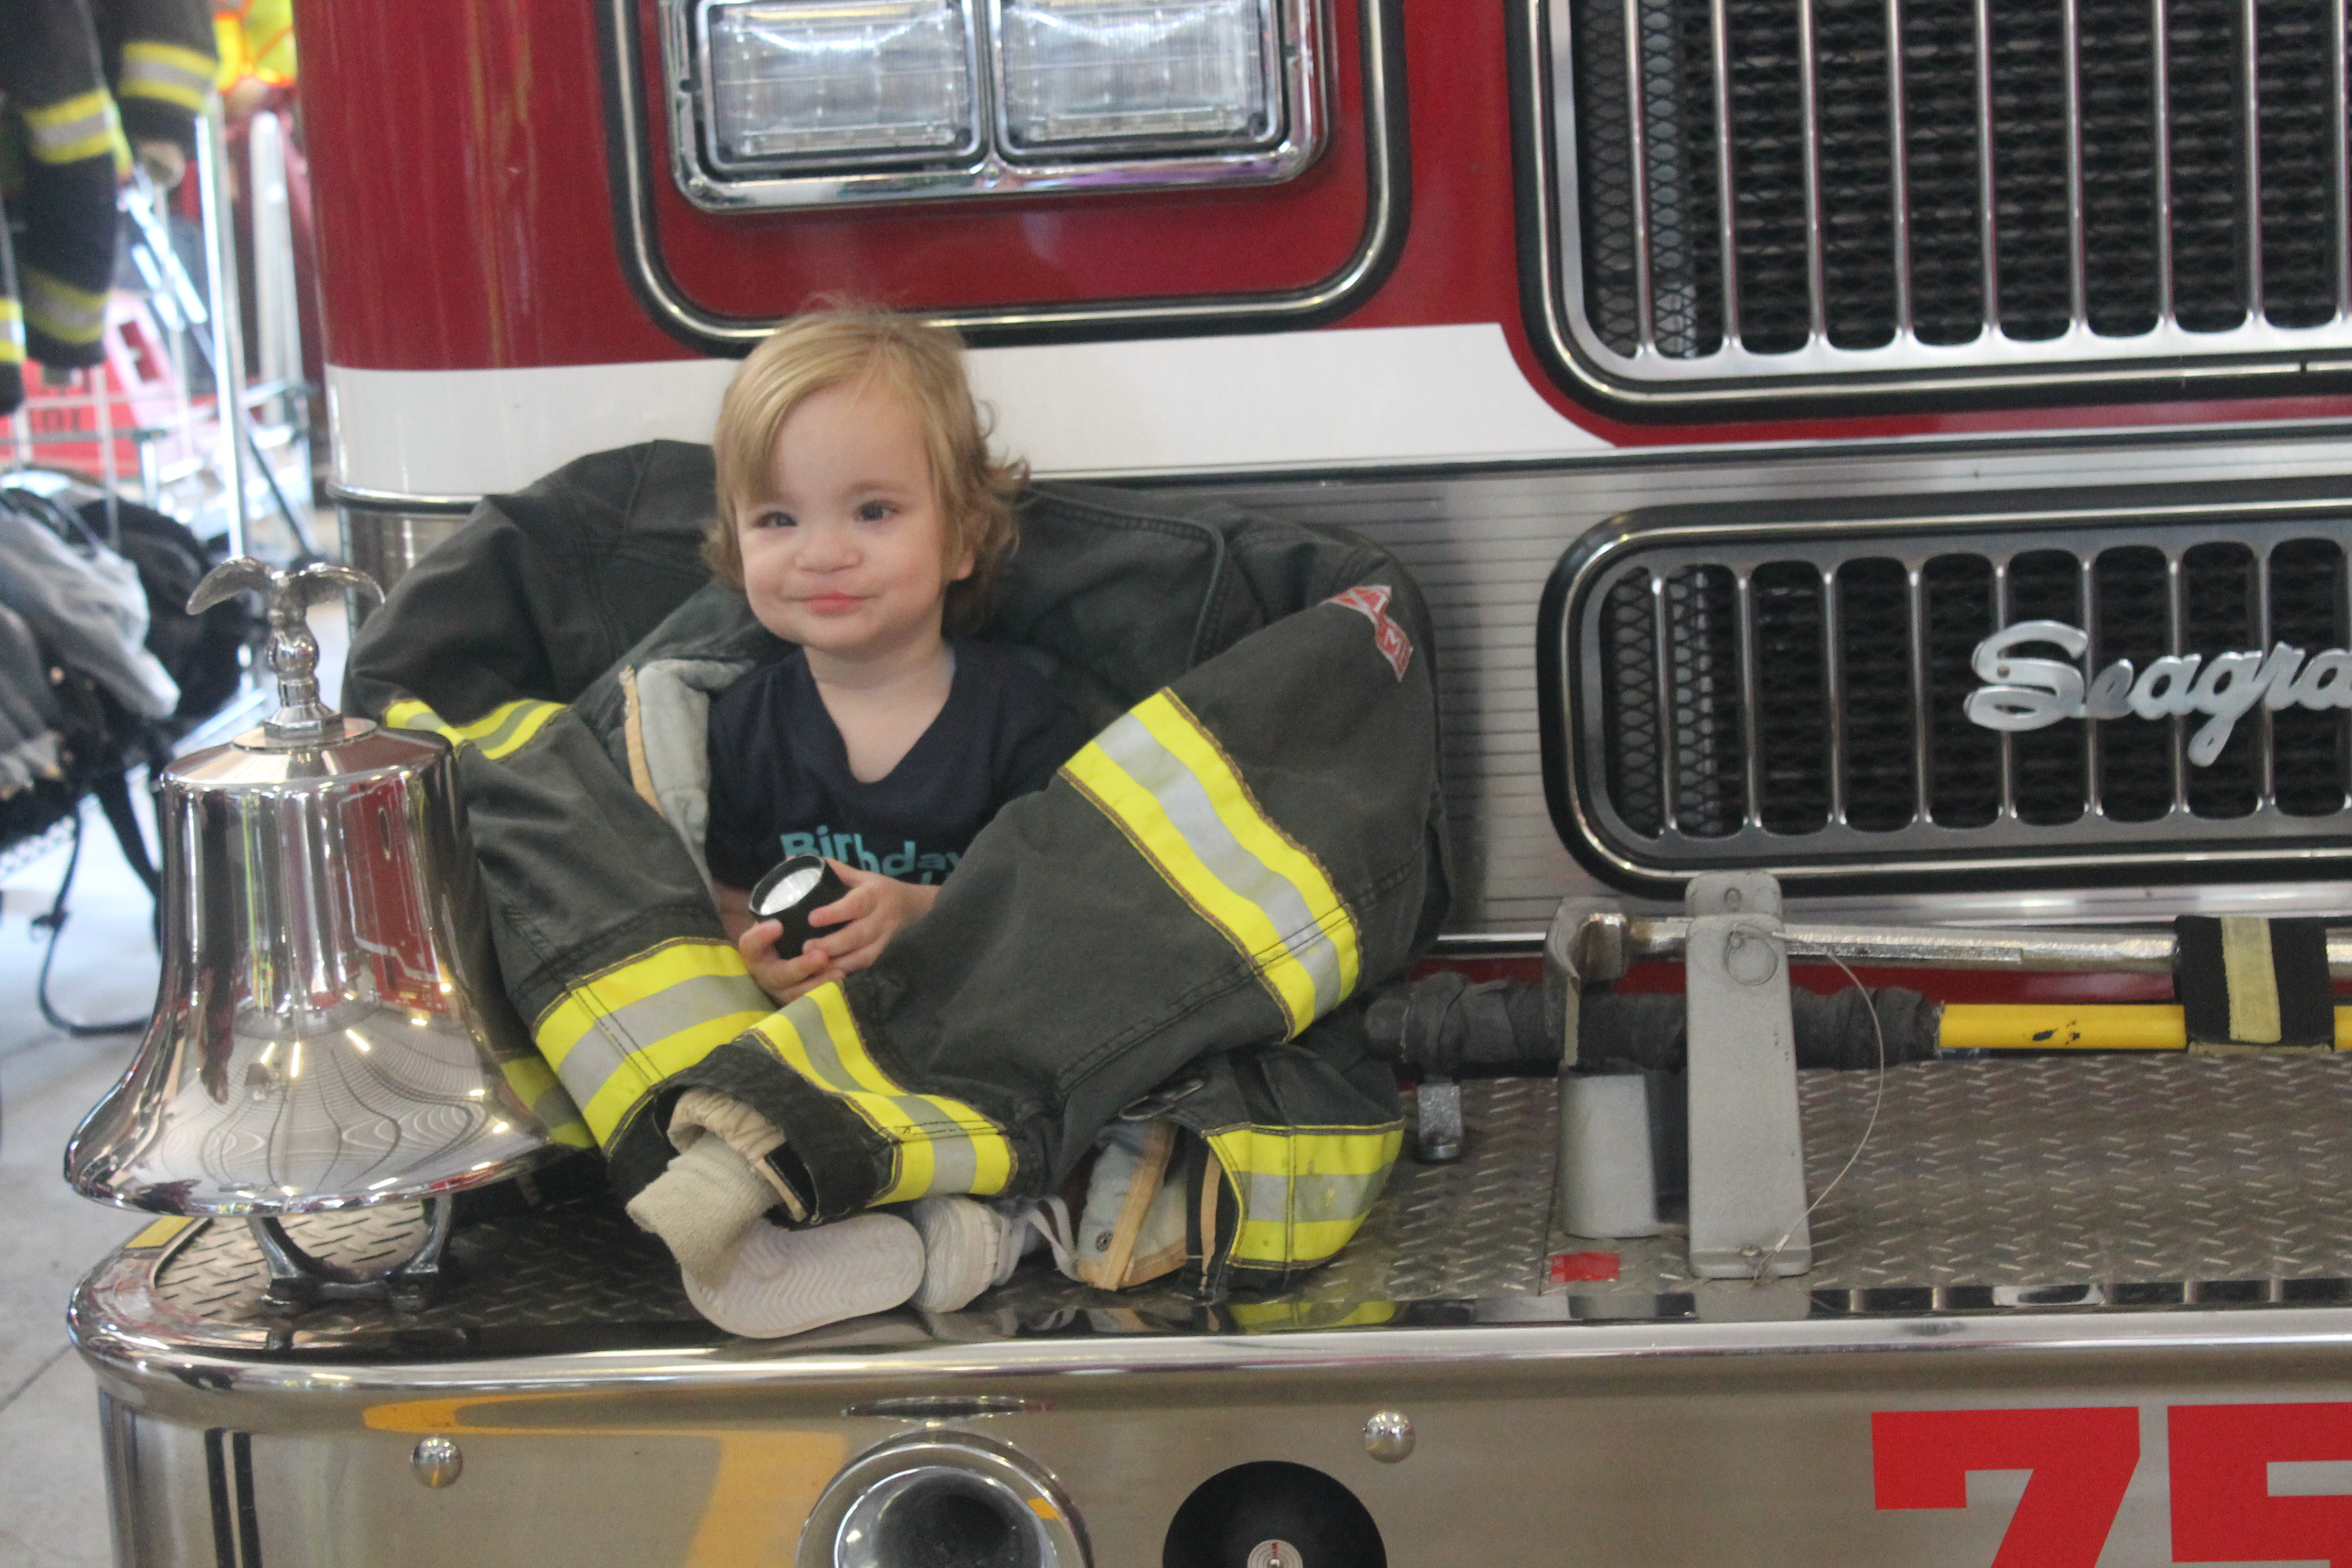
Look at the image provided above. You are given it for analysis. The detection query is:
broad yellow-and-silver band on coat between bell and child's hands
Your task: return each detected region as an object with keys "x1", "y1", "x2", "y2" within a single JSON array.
[{"x1": 531, "y1": 938, "x2": 769, "y2": 1147}]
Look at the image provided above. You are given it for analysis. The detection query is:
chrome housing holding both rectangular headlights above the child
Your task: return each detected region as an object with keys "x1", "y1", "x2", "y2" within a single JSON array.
[{"x1": 661, "y1": 0, "x2": 1324, "y2": 211}]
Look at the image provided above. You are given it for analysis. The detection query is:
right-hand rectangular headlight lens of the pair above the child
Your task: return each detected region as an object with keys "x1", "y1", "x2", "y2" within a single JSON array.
[{"x1": 997, "y1": 0, "x2": 1280, "y2": 153}]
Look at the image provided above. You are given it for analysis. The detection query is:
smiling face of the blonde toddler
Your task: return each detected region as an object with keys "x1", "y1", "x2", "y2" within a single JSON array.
[{"x1": 736, "y1": 383, "x2": 971, "y2": 663}]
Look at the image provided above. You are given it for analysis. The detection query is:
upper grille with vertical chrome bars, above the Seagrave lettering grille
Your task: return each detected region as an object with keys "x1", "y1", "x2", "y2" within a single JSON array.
[{"x1": 1545, "y1": 0, "x2": 2352, "y2": 395}]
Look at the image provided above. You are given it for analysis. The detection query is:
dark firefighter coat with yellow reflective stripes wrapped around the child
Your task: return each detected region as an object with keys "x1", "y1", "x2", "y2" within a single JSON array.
[{"x1": 329, "y1": 442, "x2": 1446, "y2": 1283}]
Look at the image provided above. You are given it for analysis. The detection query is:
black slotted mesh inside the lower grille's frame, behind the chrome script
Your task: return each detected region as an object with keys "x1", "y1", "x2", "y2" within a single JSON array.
[{"x1": 1594, "y1": 538, "x2": 2352, "y2": 839}]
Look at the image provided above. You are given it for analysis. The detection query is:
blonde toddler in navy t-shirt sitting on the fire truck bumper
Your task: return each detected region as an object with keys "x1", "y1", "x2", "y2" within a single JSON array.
[{"x1": 630, "y1": 311, "x2": 1087, "y2": 1338}]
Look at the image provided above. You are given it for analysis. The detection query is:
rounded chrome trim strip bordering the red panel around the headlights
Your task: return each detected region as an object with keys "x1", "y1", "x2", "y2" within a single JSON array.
[{"x1": 602, "y1": 0, "x2": 1402, "y2": 352}]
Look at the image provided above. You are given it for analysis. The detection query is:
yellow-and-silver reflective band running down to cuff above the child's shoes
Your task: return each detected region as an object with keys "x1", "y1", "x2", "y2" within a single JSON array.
[{"x1": 753, "y1": 981, "x2": 1014, "y2": 1204}]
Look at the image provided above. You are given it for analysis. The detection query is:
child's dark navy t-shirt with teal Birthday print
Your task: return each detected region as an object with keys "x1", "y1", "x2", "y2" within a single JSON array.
[{"x1": 703, "y1": 637, "x2": 1087, "y2": 889}]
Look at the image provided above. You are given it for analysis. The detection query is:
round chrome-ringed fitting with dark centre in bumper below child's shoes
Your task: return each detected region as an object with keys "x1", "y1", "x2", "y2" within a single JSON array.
[{"x1": 795, "y1": 1431, "x2": 1091, "y2": 1568}]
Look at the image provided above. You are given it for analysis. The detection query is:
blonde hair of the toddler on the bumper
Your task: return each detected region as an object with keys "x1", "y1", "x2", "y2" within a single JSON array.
[{"x1": 703, "y1": 306, "x2": 1028, "y2": 630}]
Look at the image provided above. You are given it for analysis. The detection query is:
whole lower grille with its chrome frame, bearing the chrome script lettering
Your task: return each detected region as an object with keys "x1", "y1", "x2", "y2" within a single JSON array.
[{"x1": 1555, "y1": 517, "x2": 2352, "y2": 874}]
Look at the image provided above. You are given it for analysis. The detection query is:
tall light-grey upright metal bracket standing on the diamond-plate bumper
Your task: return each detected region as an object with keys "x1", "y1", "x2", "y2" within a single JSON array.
[{"x1": 1684, "y1": 872, "x2": 1814, "y2": 1279}]
